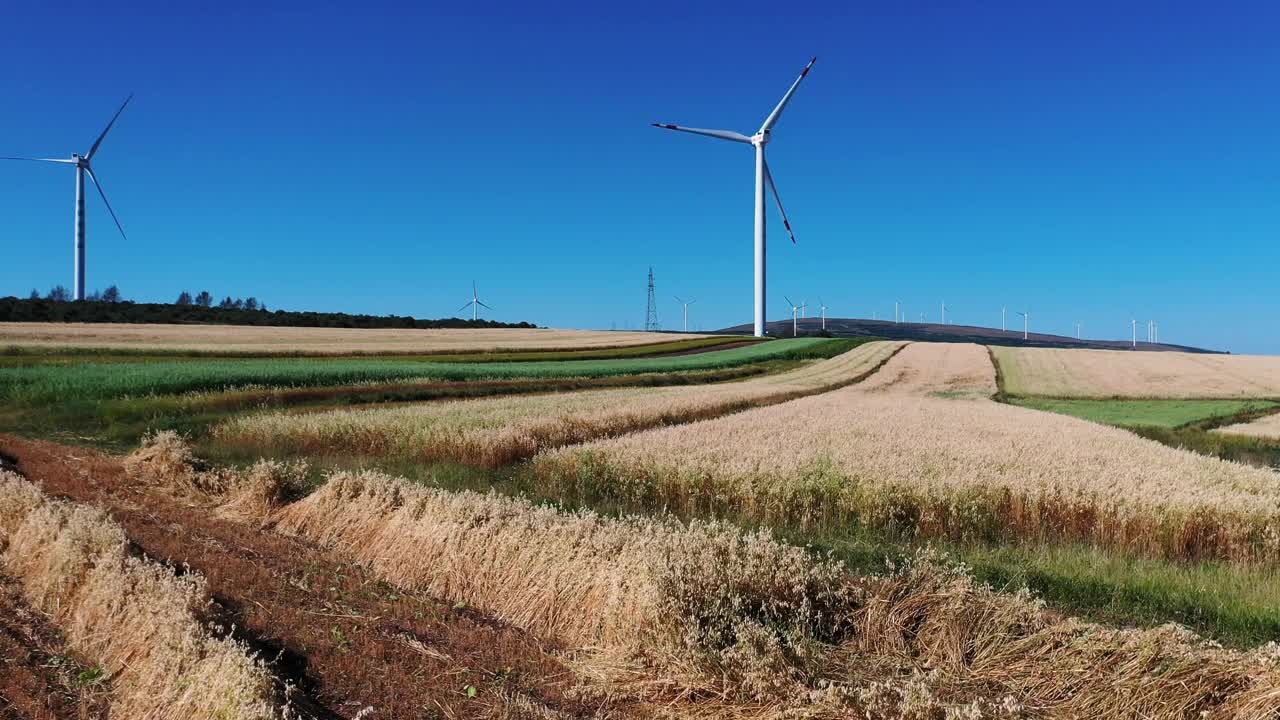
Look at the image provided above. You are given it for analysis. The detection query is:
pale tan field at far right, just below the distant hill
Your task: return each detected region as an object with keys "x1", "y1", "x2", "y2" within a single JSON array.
[{"x1": 992, "y1": 347, "x2": 1280, "y2": 398}]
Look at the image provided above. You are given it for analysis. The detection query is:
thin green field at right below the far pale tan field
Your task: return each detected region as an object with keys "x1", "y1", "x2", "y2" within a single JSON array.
[{"x1": 1009, "y1": 397, "x2": 1280, "y2": 422}]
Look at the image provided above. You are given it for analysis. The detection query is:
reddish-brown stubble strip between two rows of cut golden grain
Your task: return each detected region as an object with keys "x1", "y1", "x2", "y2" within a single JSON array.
[{"x1": 0, "y1": 434, "x2": 636, "y2": 719}]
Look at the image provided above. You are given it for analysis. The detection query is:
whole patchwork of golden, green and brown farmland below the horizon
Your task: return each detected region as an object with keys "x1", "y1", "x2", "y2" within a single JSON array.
[{"x1": 0, "y1": 322, "x2": 1280, "y2": 720}]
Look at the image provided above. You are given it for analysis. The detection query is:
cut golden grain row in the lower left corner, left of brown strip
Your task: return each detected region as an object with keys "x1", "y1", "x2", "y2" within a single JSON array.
[{"x1": 0, "y1": 470, "x2": 278, "y2": 720}]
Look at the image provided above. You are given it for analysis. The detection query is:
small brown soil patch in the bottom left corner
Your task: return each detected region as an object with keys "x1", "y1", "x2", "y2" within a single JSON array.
[{"x1": 0, "y1": 575, "x2": 106, "y2": 720}]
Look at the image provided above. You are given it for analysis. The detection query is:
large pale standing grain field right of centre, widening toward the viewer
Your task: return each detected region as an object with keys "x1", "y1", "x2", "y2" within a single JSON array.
[{"x1": 534, "y1": 343, "x2": 1280, "y2": 561}]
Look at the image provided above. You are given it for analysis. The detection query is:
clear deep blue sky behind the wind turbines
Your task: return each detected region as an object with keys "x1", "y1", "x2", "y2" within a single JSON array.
[{"x1": 0, "y1": 1, "x2": 1280, "y2": 352}]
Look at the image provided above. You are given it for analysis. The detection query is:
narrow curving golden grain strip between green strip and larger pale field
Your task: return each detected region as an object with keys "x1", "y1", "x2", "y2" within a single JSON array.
[{"x1": 215, "y1": 342, "x2": 906, "y2": 466}]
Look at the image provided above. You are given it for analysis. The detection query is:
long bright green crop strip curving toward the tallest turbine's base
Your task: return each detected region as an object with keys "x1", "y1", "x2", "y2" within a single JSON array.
[{"x1": 0, "y1": 338, "x2": 850, "y2": 404}]
